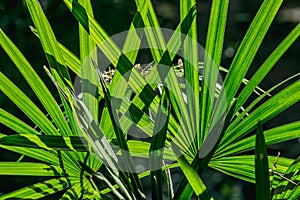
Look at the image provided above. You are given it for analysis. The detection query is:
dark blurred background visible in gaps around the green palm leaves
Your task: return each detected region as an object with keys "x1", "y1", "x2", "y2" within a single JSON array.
[{"x1": 0, "y1": 0, "x2": 300, "y2": 200}]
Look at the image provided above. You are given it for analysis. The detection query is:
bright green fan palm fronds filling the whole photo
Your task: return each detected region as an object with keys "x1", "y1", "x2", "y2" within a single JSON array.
[{"x1": 0, "y1": 0, "x2": 300, "y2": 199}]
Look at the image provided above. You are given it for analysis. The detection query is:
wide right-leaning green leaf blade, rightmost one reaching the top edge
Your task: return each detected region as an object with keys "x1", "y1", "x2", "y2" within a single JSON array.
[{"x1": 212, "y1": 0, "x2": 282, "y2": 124}]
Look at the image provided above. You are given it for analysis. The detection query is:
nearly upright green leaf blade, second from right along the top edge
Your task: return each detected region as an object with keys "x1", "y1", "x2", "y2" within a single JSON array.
[{"x1": 199, "y1": 0, "x2": 229, "y2": 144}]
